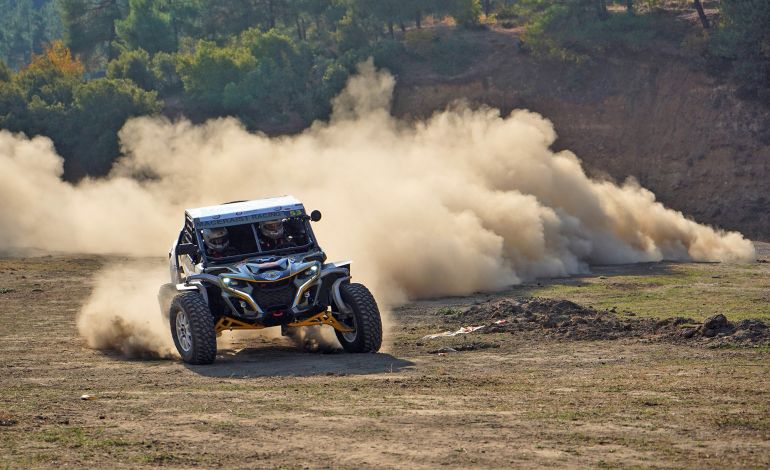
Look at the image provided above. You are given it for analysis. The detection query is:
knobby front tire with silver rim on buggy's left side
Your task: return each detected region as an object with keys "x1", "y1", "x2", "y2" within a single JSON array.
[{"x1": 169, "y1": 292, "x2": 217, "y2": 364}]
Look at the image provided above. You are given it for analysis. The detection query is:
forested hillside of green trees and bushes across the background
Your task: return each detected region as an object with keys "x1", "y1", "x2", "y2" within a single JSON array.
[{"x1": 0, "y1": 0, "x2": 770, "y2": 180}]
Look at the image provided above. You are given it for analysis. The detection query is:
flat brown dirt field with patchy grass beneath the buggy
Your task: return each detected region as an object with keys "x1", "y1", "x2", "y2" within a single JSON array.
[{"x1": 0, "y1": 245, "x2": 770, "y2": 468}]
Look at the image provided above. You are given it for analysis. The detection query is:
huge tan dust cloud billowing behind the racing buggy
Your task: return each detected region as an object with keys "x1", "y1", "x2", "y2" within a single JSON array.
[{"x1": 0, "y1": 62, "x2": 755, "y2": 358}]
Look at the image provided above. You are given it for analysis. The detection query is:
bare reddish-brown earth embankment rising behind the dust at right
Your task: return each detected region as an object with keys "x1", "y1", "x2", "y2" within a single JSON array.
[{"x1": 394, "y1": 27, "x2": 770, "y2": 240}]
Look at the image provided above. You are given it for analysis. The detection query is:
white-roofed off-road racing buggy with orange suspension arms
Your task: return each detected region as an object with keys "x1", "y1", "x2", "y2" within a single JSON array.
[{"x1": 158, "y1": 196, "x2": 382, "y2": 364}]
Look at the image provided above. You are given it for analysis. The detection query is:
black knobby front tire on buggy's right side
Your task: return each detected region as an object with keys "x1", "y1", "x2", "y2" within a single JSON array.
[{"x1": 335, "y1": 284, "x2": 382, "y2": 353}]
